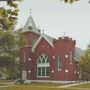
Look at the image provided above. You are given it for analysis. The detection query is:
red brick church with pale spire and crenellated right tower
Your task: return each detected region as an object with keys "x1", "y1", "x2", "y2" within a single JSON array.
[{"x1": 21, "y1": 16, "x2": 78, "y2": 82}]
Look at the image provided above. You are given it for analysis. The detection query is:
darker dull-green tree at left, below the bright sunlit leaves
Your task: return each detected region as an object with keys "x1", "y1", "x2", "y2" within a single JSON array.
[{"x1": 0, "y1": 30, "x2": 24, "y2": 78}]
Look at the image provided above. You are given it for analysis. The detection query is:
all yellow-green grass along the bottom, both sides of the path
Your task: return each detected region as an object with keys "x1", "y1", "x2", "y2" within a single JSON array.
[{"x1": 0, "y1": 83, "x2": 90, "y2": 90}]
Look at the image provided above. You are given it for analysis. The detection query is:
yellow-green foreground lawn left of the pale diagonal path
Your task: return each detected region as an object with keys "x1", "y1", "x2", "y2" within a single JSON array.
[{"x1": 0, "y1": 83, "x2": 77, "y2": 90}]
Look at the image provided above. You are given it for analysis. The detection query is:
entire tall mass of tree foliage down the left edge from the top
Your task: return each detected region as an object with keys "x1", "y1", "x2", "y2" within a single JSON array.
[{"x1": 0, "y1": 0, "x2": 23, "y2": 78}]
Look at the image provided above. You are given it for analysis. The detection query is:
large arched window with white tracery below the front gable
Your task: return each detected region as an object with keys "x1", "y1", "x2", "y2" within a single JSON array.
[{"x1": 37, "y1": 54, "x2": 50, "y2": 77}]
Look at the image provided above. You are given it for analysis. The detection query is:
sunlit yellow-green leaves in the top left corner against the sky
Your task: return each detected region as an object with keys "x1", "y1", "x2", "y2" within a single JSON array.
[{"x1": 0, "y1": 0, "x2": 22, "y2": 30}]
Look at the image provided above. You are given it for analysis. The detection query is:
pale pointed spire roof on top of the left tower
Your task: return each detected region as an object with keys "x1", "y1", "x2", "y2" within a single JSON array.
[{"x1": 22, "y1": 16, "x2": 40, "y2": 34}]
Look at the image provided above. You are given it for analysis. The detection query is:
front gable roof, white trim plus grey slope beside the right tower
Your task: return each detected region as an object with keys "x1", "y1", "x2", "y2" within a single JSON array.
[{"x1": 32, "y1": 34, "x2": 54, "y2": 52}]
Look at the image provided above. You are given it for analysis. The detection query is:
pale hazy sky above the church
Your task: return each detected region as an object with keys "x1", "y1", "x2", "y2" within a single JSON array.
[{"x1": 0, "y1": 0, "x2": 90, "y2": 49}]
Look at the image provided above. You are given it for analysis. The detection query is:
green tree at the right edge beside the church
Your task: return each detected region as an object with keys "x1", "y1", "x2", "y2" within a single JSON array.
[{"x1": 79, "y1": 44, "x2": 90, "y2": 79}]
